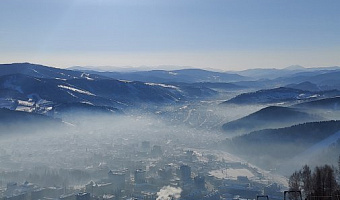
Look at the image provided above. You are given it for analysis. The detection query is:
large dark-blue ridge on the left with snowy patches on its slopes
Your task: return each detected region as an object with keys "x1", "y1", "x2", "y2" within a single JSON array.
[{"x1": 0, "y1": 63, "x2": 223, "y2": 113}]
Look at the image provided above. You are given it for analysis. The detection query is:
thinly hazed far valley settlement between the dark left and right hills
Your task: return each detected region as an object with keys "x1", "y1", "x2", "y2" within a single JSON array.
[{"x1": 138, "y1": 100, "x2": 265, "y2": 137}]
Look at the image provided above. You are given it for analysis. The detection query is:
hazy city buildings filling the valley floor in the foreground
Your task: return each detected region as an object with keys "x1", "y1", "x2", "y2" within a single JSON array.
[{"x1": 0, "y1": 141, "x2": 283, "y2": 200}]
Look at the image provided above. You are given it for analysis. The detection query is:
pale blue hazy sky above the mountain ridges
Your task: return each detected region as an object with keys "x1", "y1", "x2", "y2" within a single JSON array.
[{"x1": 0, "y1": 0, "x2": 340, "y2": 70}]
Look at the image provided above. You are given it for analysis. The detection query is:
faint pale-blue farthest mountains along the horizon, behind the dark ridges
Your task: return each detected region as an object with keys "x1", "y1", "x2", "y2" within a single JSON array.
[{"x1": 71, "y1": 65, "x2": 340, "y2": 91}]
